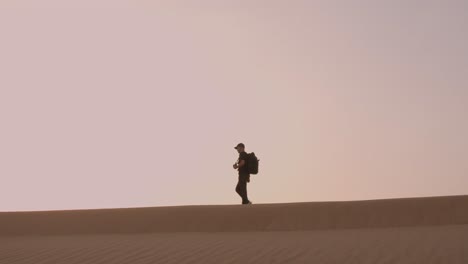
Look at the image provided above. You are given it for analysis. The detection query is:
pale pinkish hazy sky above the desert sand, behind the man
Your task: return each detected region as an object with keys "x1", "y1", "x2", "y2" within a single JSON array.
[{"x1": 0, "y1": 0, "x2": 468, "y2": 211}]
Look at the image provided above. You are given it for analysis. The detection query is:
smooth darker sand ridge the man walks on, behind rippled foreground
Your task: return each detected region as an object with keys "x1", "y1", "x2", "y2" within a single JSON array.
[{"x1": 0, "y1": 195, "x2": 468, "y2": 236}]
